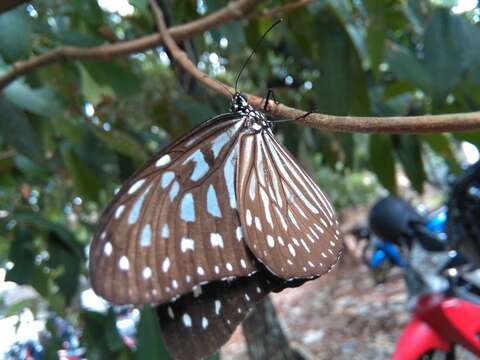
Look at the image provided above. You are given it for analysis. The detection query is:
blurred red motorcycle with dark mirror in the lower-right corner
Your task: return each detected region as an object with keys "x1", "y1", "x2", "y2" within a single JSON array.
[{"x1": 370, "y1": 197, "x2": 480, "y2": 360}]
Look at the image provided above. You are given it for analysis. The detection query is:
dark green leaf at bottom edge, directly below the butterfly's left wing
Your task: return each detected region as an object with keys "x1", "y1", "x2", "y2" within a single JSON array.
[{"x1": 135, "y1": 305, "x2": 170, "y2": 360}]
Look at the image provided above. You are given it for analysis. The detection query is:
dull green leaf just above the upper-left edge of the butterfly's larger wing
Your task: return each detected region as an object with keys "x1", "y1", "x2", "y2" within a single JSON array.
[{"x1": 90, "y1": 126, "x2": 147, "y2": 161}]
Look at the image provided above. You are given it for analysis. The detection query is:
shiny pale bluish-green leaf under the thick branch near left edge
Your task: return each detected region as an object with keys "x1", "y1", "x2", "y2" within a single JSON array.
[{"x1": 4, "y1": 80, "x2": 62, "y2": 117}]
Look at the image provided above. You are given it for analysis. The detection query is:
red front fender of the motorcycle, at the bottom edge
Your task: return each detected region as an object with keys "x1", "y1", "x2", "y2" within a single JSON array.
[{"x1": 392, "y1": 316, "x2": 451, "y2": 360}]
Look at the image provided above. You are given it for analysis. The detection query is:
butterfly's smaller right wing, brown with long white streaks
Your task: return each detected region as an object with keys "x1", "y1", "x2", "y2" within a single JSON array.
[{"x1": 237, "y1": 129, "x2": 341, "y2": 279}]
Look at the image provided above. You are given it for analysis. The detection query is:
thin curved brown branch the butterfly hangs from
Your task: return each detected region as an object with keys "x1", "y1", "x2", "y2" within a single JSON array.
[{"x1": 150, "y1": 0, "x2": 480, "y2": 134}]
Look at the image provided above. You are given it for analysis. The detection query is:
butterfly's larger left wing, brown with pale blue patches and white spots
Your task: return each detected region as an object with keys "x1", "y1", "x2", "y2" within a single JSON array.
[{"x1": 90, "y1": 115, "x2": 255, "y2": 304}]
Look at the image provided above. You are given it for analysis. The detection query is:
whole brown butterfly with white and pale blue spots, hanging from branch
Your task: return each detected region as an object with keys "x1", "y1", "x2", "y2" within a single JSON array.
[{"x1": 90, "y1": 92, "x2": 342, "y2": 359}]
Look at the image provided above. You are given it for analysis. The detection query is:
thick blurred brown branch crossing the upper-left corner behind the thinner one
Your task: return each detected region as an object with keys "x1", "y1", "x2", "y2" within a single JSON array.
[{"x1": 0, "y1": 0, "x2": 257, "y2": 91}]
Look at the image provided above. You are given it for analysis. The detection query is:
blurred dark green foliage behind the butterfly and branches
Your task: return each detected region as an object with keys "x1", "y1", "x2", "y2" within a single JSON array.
[{"x1": 0, "y1": 0, "x2": 480, "y2": 359}]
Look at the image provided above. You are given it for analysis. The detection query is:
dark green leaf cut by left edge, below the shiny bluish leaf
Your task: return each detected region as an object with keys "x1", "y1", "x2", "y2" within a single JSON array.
[{"x1": 0, "y1": 96, "x2": 43, "y2": 162}]
